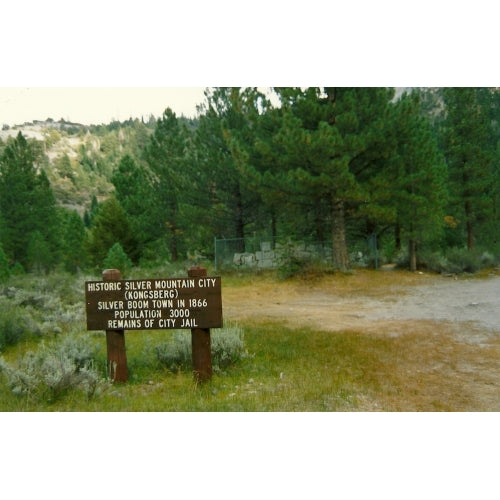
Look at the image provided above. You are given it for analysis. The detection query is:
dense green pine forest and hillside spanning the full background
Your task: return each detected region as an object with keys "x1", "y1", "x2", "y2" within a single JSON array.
[{"x1": 0, "y1": 87, "x2": 500, "y2": 282}]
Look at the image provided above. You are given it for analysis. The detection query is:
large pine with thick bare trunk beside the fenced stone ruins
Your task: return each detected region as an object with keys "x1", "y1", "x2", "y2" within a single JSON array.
[{"x1": 268, "y1": 87, "x2": 393, "y2": 270}]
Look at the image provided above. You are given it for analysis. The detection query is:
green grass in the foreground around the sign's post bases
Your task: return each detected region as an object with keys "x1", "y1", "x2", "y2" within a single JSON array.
[{"x1": 0, "y1": 324, "x2": 492, "y2": 412}]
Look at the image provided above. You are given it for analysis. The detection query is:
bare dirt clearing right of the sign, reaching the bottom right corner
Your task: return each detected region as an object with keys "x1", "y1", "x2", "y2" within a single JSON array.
[{"x1": 223, "y1": 271, "x2": 500, "y2": 411}]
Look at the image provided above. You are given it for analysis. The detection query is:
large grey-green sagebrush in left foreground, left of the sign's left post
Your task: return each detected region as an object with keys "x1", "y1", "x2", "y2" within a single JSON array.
[{"x1": 0, "y1": 337, "x2": 107, "y2": 402}]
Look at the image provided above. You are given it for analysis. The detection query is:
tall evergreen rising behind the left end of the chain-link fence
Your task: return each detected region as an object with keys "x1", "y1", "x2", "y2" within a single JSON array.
[{"x1": 196, "y1": 87, "x2": 266, "y2": 251}]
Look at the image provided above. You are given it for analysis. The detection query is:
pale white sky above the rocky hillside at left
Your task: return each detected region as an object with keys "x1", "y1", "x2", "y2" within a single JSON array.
[{"x1": 0, "y1": 87, "x2": 204, "y2": 126}]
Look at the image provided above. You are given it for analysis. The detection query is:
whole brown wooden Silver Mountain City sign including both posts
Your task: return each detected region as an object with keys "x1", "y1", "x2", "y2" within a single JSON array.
[{"x1": 85, "y1": 266, "x2": 222, "y2": 382}]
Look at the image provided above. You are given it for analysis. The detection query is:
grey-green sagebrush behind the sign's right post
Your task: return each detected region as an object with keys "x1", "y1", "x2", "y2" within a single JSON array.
[{"x1": 154, "y1": 325, "x2": 248, "y2": 372}]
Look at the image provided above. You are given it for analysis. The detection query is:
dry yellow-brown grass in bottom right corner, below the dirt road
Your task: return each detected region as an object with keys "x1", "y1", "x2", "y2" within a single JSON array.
[{"x1": 358, "y1": 321, "x2": 500, "y2": 411}]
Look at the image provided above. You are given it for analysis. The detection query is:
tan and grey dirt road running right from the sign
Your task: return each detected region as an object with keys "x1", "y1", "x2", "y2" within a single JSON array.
[{"x1": 224, "y1": 273, "x2": 500, "y2": 340}]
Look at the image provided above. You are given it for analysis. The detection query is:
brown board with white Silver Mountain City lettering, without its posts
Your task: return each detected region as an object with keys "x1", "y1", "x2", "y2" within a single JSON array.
[{"x1": 85, "y1": 276, "x2": 222, "y2": 330}]
